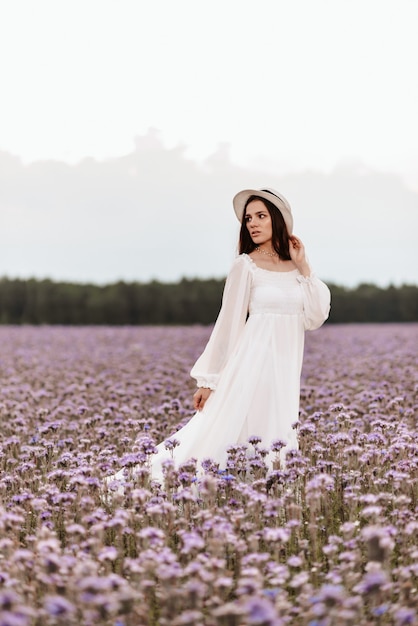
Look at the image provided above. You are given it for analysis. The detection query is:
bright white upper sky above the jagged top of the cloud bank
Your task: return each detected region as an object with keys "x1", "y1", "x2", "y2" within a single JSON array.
[{"x1": 0, "y1": 0, "x2": 418, "y2": 189}]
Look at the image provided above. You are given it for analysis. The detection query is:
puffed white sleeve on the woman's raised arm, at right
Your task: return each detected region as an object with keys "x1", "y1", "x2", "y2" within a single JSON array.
[{"x1": 297, "y1": 274, "x2": 331, "y2": 330}]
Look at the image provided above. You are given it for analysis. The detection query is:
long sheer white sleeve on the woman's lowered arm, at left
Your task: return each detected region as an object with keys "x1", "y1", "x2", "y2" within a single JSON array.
[{"x1": 190, "y1": 255, "x2": 252, "y2": 389}]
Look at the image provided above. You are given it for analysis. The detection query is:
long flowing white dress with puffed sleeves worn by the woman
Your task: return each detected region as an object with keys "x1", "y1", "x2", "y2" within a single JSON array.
[{"x1": 112, "y1": 254, "x2": 330, "y2": 479}]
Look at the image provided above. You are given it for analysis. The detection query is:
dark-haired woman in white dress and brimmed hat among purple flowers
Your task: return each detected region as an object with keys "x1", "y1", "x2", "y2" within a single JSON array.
[{"x1": 112, "y1": 189, "x2": 330, "y2": 486}]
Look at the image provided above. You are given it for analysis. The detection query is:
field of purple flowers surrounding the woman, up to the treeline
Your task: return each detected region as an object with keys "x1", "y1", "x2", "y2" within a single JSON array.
[{"x1": 0, "y1": 324, "x2": 418, "y2": 626}]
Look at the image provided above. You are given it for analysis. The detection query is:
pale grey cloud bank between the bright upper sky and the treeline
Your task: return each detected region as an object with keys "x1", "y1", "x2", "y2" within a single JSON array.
[{"x1": 0, "y1": 132, "x2": 418, "y2": 285}]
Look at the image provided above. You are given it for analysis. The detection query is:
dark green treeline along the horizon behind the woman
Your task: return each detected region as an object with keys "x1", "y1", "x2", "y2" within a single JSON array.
[{"x1": 0, "y1": 278, "x2": 418, "y2": 325}]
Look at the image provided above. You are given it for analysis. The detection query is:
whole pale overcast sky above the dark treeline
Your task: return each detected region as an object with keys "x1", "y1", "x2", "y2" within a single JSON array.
[{"x1": 0, "y1": 0, "x2": 418, "y2": 286}]
